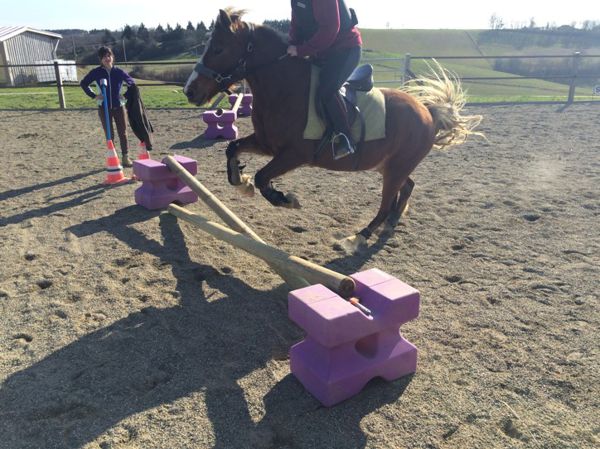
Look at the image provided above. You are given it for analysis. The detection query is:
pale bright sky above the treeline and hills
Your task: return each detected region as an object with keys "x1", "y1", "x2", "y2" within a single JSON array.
[{"x1": 0, "y1": 0, "x2": 600, "y2": 30}]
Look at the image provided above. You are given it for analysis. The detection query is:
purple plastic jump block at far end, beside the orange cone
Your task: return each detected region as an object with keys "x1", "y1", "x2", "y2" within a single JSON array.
[{"x1": 133, "y1": 156, "x2": 198, "y2": 210}]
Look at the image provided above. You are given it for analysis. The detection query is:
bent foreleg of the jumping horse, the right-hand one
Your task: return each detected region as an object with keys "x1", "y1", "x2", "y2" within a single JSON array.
[{"x1": 254, "y1": 150, "x2": 304, "y2": 208}]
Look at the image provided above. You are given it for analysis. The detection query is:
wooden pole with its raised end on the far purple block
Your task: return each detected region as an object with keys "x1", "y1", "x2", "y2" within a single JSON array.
[{"x1": 165, "y1": 156, "x2": 310, "y2": 289}]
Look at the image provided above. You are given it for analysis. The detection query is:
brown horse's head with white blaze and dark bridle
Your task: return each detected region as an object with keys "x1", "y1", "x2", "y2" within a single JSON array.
[{"x1": 183, "y1": 9, "x2": 253, "y2": 105}]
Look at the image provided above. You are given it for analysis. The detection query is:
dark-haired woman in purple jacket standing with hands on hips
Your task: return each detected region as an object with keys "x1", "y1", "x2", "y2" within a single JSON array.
[{"x1": 80, "y1": 47, "x2": 135, "y2": 167}]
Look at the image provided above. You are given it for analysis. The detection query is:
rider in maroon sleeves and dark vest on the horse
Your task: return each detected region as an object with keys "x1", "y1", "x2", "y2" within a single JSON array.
[{"x1": 287, "y1": 0, "x2": 362, "y2": 159}]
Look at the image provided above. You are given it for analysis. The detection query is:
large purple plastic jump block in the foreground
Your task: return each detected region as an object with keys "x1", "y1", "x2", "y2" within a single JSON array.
[{"x1": 288, "y1": 269, "x2": 420, "y2": 407}]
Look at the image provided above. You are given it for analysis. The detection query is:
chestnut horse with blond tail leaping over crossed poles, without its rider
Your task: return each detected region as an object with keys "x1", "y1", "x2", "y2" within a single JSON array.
[{"x1": 183, "y1": 8, "x2": 481, "y2": 252}]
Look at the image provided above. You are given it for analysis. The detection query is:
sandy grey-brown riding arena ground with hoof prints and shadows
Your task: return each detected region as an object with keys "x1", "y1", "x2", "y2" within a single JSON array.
[{"x1": 0, "y1": 105, "x2": 600, "y2": 449}]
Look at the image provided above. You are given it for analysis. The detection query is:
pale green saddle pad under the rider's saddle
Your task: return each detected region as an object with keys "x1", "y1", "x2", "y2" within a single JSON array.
[{"x1": 302, "y1": 65, "x2": 385, "y2": 142}]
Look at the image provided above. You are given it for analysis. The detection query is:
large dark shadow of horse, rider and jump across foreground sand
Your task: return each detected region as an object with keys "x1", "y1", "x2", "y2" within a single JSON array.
[{"x1": 0, "y1": 207, "x2": 408, "y2": 449}]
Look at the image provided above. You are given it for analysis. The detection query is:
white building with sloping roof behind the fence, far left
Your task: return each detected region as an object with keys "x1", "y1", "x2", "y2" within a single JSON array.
[{"x1": 0, "y1": 27, "x2": 67, "y2": 86}]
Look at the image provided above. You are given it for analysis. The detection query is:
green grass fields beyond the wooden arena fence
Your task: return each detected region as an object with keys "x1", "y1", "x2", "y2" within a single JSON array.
[{"x1": 0, "y1": 29, "x2": 600, "y2": 109}]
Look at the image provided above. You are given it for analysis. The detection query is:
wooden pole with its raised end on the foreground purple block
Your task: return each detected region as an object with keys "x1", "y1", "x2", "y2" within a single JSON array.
[{"x1": 168, "y1": 204, "x2": 356, "y2": 298}]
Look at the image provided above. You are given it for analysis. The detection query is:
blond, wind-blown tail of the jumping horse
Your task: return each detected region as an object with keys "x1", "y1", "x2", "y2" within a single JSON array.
[{"x1": 400, "y1": 59, "x2": 485, "y2": 149}]
